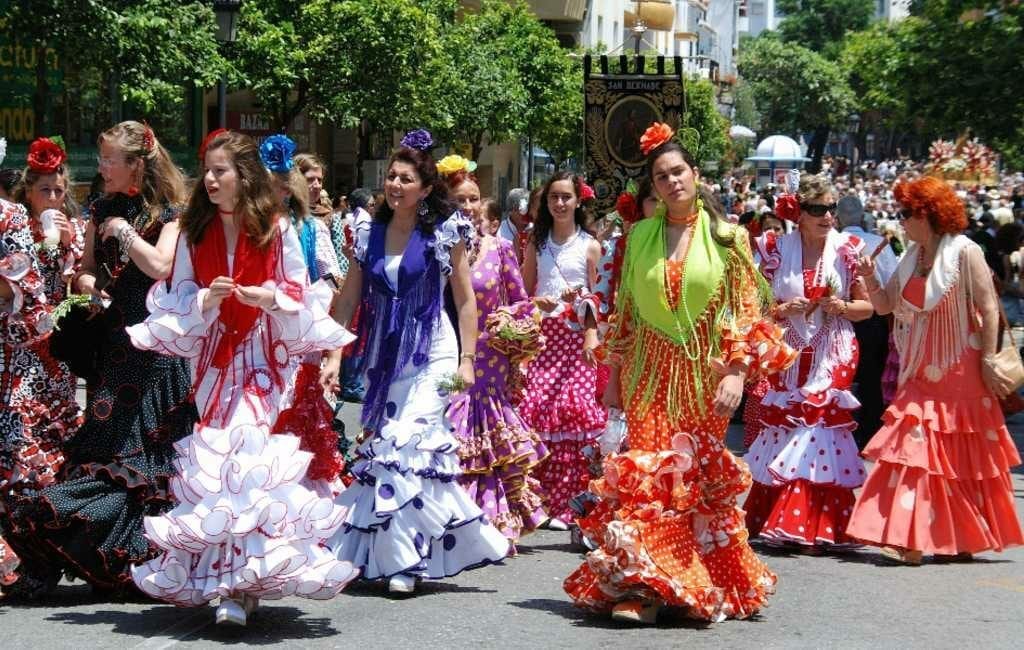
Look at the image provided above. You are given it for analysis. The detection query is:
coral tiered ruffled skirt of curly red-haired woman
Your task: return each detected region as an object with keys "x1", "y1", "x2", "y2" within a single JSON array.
[{"x1": 847, "y1": 370, "x2": 1024, "y2": 555}]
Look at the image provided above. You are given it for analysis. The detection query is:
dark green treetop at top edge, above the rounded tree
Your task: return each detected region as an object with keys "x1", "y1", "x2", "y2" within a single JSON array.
[{"x1": 775, "y1": 0, "x2": 874, "y2": 59}]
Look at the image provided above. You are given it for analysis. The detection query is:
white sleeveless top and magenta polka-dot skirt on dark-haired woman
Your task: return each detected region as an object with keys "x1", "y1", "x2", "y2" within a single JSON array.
[{"x1": 519, "y1": 228, "x2": 607, "y2": 524}]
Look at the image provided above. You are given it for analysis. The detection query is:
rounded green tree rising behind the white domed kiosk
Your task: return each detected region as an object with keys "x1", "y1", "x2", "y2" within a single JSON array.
[{"x1": 738, "y1": 38, "x2": 856, "y2": 169}]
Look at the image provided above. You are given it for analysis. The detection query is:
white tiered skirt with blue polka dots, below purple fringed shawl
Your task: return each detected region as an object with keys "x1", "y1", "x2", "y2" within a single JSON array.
[{"x1": 327, "y1": 418, "x2": 509, "y2": 579}]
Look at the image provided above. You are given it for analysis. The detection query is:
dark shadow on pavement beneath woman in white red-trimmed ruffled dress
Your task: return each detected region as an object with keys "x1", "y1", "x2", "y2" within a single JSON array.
[{"x1": 47, "y1": 605, "x2": 340, "y2": 646}]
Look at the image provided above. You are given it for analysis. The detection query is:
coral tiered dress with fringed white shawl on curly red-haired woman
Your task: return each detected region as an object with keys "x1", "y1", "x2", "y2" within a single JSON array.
[{"x1": 847, "y1": 235, "x2": 1024, "y2": 556}]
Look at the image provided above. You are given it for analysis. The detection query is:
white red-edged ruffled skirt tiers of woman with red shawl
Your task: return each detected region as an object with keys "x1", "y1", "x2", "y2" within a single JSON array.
[{"x1": 132, "y1": 425, "x2": 357, "y2": 606}]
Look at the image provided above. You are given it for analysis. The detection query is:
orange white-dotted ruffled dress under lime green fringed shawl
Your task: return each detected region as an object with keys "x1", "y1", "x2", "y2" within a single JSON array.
[{"x1": 563, "y1": 252, "x2": 795, "y2": 621}]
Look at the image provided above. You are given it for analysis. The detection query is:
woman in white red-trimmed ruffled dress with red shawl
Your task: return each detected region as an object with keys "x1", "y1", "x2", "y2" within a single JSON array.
[{"x1": 128, "y1": 132, "x2": 356, "y2": 624}]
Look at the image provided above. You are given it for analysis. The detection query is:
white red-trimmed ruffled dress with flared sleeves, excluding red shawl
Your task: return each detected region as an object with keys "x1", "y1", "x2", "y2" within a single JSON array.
[{"x1": 128, "y1": 219, "x2": 358, "y2": 606}]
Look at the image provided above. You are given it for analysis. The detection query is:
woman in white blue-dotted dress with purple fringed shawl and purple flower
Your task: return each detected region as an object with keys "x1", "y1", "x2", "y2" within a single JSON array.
[{"x1": 323, "y1": 136, "x2": 509, "y2": 594}]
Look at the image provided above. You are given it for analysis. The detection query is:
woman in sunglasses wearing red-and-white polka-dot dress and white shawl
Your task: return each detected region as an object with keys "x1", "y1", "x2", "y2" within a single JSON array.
[{"x1": 743, "y1": 174, "x2": 872, "y2": 548}]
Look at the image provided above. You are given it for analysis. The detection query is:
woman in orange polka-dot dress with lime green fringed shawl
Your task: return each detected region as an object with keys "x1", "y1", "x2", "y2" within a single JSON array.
[{"x1": 564, "y1": 125, "x2": 794, "y2": 622}]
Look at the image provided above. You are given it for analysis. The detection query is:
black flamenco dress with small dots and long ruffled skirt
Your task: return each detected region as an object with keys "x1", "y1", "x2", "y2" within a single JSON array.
[{"x1": 6, "y1": 194, "x2": 197, "y2": 590}]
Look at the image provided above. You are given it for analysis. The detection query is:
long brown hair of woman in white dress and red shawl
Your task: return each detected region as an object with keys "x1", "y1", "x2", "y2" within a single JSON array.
[{"x1": 178, "y1": 131, "x2": 280, "y2": 249}]
